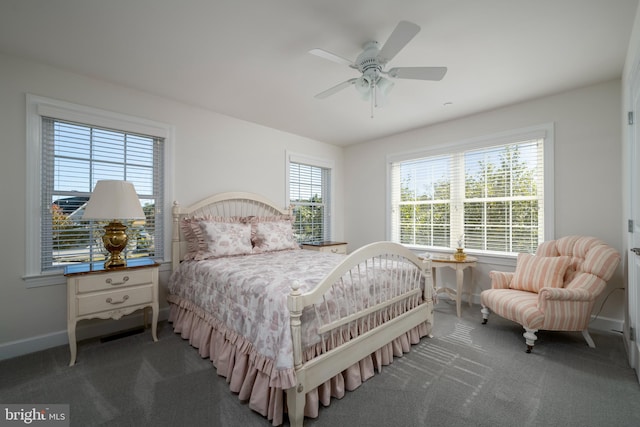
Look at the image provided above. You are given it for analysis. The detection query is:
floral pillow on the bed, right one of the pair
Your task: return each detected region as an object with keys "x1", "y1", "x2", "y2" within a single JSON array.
[{"x1": 251, "y1": 215, "x2": 300, "y2": 253}]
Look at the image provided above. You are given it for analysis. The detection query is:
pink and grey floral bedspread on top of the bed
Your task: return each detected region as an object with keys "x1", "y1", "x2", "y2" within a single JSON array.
[{"x1": 169, "y1": 250, "x2": 345, "y2": 369}]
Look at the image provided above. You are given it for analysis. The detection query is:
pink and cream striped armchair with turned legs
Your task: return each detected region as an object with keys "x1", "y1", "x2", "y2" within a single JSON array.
[{"x1": 480, "y1": 236, "x2": 620, "y2": 353}]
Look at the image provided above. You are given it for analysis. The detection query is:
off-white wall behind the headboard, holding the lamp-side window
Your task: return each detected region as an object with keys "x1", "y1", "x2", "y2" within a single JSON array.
[{"x1": 0, "y1": 55, "x2": 344, "y2": 359}]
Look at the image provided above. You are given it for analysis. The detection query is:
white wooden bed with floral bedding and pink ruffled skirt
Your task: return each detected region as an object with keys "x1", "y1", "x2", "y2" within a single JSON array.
[{"x1": 167, "y1": 192, "x2": 433, "y2": 426}]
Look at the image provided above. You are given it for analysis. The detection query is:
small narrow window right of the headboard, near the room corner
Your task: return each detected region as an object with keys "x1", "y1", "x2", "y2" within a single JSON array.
[{"x1": 288, "y1": 156, "x2": 331, "y2": 243}]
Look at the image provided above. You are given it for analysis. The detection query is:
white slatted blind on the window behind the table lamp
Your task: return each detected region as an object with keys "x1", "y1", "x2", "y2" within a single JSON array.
[{"x1": 41, "y1": 117, "x2": 164, "y2": 271}]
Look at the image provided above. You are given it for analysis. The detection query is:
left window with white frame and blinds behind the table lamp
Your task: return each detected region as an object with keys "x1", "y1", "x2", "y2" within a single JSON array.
[{"x1": 27, "y1": 96, "x2": 169, "y2": 284}]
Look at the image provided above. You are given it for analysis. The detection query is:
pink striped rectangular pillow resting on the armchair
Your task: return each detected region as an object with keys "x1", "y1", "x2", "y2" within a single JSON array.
[{"x1": 509, "y1": 254, "x2": 571, "y2": 293}]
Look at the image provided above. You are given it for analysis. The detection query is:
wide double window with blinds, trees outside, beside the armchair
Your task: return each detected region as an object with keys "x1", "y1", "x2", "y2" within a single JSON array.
[{"x1": 390, "y1": 128, "x2": 553, "y2": 254}]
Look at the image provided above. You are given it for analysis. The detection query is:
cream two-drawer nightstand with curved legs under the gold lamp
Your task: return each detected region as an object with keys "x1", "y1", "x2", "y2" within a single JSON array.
[{"x1": 64, "y1": 258, "x2": 159, "y2": 366}]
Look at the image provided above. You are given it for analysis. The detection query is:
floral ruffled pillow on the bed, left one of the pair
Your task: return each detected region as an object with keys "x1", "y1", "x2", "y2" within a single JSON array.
[{"x1": 196, "y1": 221, "x2": 252, "y2": 259}]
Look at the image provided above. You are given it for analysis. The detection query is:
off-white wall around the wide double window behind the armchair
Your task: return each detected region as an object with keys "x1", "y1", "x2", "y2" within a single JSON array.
[{"x1": 344, "y1": 80, "x2": 624, "y2": 330}]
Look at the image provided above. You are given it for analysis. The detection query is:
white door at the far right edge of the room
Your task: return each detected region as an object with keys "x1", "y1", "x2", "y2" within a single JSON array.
[{"x1": 625, "y1": 68, "x2": 640, "y2": 380}]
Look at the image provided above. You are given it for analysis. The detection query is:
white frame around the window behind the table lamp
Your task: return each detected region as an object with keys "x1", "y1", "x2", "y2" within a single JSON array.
[{"x1": 23, "y1": 94, "x2": 175, "y2": 288}]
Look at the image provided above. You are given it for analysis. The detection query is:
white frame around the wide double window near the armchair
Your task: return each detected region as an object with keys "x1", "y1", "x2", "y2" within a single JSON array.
[{"x1": 386, "y1": 123, "x2": 555, "y2": 258}]
